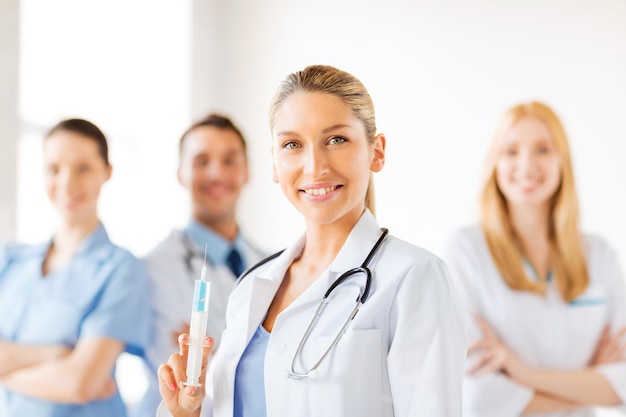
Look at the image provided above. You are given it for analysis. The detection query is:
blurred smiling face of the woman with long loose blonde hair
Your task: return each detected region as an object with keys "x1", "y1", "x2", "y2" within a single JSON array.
[{"x1": 496, "y1": 117, "x2": 561, "y2": 207}]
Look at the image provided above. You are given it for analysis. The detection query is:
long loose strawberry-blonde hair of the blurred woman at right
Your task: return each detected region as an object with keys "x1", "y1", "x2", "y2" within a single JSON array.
[{"x1": 481, "y1": 102, "x2": 589, "y2": 301}]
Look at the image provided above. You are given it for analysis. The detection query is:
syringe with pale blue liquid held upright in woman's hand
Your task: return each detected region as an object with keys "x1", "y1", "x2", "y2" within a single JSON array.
[{"x1": 185, "y1": 246, "x2": 211, "y2": 387}]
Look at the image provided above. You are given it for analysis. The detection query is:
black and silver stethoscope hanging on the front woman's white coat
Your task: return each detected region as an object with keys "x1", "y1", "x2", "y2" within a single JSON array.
[{"x1": 287, "y1": 228, "x2": 389, "y2": 379}]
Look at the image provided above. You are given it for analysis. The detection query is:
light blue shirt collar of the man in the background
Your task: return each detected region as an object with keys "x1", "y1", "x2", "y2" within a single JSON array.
[{"x1": 184, "y1": 219, "x2": 245, "y2": 265}]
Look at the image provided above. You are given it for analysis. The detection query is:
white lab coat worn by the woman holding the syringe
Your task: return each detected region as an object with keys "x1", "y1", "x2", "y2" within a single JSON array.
[{"x1": 160, "y1": 211, "x2": 467, "y2": 417}]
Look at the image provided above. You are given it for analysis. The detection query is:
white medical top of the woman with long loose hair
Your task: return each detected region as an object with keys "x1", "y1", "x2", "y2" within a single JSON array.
[{"x1": 444, "y1": 226, "x2": 626, "y2": 417}]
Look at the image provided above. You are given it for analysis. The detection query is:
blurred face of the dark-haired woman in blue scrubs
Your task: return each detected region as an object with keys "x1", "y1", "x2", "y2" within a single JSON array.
[{"x1": 43, "y1": 130, "x2": 111, "y2": 225}]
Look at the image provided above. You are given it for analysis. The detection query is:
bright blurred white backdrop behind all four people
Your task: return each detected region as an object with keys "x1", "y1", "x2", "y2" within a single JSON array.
[{"x1": 0, "y1": 0, "x2": 626, "y2": 412}]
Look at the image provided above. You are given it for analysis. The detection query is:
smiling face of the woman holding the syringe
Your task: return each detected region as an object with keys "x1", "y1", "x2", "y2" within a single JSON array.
[{"x1": 272, "y1": 91, "x2": 385, "y2": 226}]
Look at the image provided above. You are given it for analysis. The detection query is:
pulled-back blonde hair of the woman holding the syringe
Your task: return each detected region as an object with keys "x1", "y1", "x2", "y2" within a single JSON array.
[{"x1": 269, "y1": 65, "x2": 376, "y2": 214}]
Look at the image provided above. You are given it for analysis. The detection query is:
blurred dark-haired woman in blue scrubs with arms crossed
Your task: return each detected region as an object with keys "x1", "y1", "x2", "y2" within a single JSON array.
[{"x1": 0, "y1": 119, "x2": 150, "y2": 417}]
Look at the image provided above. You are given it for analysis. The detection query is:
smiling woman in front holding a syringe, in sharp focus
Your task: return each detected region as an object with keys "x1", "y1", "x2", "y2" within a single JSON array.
[{"x1": 159, "y1": 65, "x2": 466, "y2": 417}]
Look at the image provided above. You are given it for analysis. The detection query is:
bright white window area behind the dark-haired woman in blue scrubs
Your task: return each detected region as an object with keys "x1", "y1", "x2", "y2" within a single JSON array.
[{"x1": 18, "y1": 0, "x2": 191, "y2": 253}]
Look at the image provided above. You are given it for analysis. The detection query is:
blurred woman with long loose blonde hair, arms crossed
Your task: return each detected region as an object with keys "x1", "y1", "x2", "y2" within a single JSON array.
[{"x1": 445, "y1": 102, "x2": 626, "y2": 417}]
